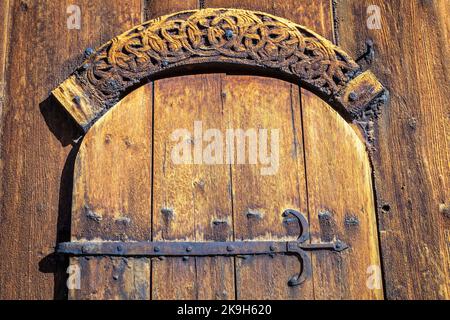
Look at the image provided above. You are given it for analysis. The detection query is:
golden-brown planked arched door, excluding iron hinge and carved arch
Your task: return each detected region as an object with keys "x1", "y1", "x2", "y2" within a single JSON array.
[{"x1": 59, "y1": 74, "x2": 382, "y2": 299}]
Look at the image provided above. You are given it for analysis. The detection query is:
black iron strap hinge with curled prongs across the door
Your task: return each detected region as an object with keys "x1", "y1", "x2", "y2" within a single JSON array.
[{"x1": 56, "y1": 209, "x2": 348, "y2": 286}]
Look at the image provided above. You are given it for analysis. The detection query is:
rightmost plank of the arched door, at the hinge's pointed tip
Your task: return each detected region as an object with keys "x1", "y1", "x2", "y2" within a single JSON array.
[{"x1": 302, "y1": 91, "x2": 383, "y2": 299}]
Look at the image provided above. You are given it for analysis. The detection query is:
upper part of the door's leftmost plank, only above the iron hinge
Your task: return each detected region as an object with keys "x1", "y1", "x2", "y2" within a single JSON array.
[{"x1": 72, "y1": 85, "x2": 153, "y2": 241}]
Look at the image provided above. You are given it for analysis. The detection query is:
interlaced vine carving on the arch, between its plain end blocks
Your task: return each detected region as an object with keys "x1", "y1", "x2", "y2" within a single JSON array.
[{"x1": 75, "y1": 9, "x2": 359, "y2": 107}]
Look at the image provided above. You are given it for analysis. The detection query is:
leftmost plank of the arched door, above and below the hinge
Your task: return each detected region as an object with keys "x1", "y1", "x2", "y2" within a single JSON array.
[{"x1": 69, "y1": 84, "x2": 152, "y2": 299}]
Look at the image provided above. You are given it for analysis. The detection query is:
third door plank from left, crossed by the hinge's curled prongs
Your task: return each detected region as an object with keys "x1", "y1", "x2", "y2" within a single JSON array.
[{"x1": 223, "y1": 76, "x2": 313, "y2": 299}]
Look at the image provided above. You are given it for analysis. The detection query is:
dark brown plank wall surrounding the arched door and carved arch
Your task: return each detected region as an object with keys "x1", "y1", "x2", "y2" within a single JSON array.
[{"x1": 0, "y1": 0, "x2": 450, "y2": 299}]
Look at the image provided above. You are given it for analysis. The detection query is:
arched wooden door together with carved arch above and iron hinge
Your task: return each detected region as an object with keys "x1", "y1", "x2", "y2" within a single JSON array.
[{"x1": 55, "y1": 9, "x2": 383, "y2": 299}]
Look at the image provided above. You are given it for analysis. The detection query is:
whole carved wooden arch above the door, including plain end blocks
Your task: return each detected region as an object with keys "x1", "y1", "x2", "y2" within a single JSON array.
[{"x1": 53, "y1": 9, "x2": 386, "y2": 131}]
